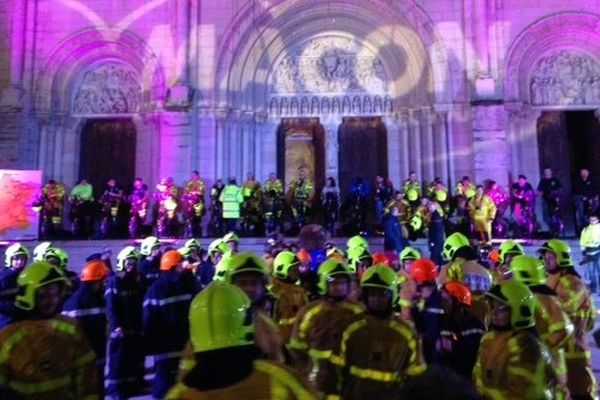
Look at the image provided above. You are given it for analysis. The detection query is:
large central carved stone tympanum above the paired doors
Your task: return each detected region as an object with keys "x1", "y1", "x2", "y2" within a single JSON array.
[{"x1": 269, "y1": 36, "x2": 392, "y2": 115}]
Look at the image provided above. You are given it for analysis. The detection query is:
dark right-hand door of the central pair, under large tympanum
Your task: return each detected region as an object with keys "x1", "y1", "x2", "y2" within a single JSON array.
[{"x1": 338, "y1": 117, "x2": 388, "y2": 198}]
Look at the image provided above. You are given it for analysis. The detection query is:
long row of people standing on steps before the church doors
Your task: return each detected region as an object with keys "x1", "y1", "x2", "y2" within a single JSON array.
[{"x1": 34, "y1": 168, "x2": 599, "y2": 242}]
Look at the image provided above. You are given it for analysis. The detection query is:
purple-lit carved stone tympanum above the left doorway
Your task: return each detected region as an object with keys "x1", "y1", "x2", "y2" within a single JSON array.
[{"x1": 73, "y1": 62, "x2": 142, "y2": 114}]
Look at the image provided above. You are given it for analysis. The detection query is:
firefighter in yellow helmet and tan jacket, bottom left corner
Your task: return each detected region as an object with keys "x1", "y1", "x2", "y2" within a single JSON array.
[{"x1": 0, "y1": 261, "x2": 100, "y2": 400}]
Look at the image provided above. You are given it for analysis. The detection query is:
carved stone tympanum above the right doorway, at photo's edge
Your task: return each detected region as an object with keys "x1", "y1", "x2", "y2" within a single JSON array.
[{"x1": 530, "y1": 51, "x2": 600, "y2": 105}]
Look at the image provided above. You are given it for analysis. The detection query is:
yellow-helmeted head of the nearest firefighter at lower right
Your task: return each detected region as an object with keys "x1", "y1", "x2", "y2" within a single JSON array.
[{"x1": 485, "y1": 281, "x2": 536, "y2": 330}]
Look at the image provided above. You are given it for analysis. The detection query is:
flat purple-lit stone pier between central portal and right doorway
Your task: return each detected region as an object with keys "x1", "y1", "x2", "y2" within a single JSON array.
[{"x1": 472, "y1": 104, "x2": 508, "y2": 187}]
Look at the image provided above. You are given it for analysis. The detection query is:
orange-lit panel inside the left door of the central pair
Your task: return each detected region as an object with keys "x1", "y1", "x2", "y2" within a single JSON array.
[{"x1": 285, "y1": 132, "x2": 315, "y2": 184}]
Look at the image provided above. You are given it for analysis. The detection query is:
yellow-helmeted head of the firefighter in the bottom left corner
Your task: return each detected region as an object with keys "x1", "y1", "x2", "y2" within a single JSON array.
[{"x1": 15, "y1": 261, "x2": 69, "y2": 318}]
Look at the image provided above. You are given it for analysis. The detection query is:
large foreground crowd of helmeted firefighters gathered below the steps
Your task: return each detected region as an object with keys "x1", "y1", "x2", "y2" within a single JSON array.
[{"x1": 0, "y1": 228, "x2": 598, "y2": 400}]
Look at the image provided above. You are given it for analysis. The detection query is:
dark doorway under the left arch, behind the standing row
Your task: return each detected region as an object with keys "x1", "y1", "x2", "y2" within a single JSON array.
[{"x1": 79, "y1": 119, "x2": 136, "y2": 199}]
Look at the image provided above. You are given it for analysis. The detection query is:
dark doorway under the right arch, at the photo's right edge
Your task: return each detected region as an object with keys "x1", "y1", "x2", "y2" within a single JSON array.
[{"x1": 529, "y1": 111, "x2": 600, "y2": 233}]
